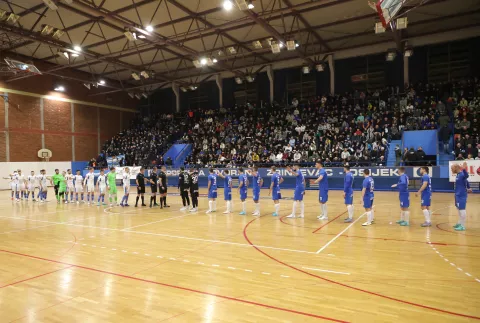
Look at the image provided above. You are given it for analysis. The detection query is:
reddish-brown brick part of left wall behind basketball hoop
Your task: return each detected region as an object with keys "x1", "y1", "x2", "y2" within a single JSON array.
[{"x1": 0, "y1": 88, "x2": 135, "y2": 162}]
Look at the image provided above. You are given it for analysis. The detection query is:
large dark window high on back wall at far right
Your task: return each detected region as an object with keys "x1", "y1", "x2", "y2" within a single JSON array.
[{"x1": 428, "y1": 41, "x2": 471, "y2": 83}]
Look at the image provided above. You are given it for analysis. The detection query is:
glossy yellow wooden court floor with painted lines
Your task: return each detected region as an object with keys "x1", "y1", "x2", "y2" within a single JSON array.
[{"x1": 0, "y1": 190, "x2": 480, "y2": 323}]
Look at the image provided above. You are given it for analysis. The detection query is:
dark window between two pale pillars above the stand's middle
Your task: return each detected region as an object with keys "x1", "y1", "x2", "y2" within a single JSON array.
[{"x1": 287, "y1": 68, "x2": 317, "y2": 103}]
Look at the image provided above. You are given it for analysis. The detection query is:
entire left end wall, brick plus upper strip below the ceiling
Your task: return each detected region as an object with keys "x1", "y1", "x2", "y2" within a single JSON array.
[{"x1": 0, "y1": 70, "x2": 138, "y2": 162}]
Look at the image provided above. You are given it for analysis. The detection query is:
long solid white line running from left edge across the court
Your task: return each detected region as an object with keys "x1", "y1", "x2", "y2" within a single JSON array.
[{"x1": 0, "y1": 216, "x2": 316, "y2": 254}]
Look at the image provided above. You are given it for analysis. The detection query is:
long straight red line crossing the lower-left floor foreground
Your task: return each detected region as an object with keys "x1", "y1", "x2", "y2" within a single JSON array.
[{"x1": 0, "y1": 249, "x2": 348, "y2": 323}]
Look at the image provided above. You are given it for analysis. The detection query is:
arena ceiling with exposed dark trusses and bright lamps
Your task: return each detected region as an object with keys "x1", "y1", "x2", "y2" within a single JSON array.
[{"x1": 0, "y1": 0, "x2": 480, "y2": 93}]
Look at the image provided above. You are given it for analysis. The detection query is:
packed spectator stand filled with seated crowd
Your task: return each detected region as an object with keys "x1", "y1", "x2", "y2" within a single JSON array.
[{"x1": 98, "y1": 81, "x2": 480, "y2": 167}]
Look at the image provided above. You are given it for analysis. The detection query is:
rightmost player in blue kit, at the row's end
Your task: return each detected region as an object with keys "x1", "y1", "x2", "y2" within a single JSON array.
[{"x1": 451, "y1": 162, "x2": 472, "y2": 231}]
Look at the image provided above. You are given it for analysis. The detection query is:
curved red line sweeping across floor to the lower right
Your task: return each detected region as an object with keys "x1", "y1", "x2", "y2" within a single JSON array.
[{"x1": 243, "y1": 218, "x2": 480, "y2": 320}]
